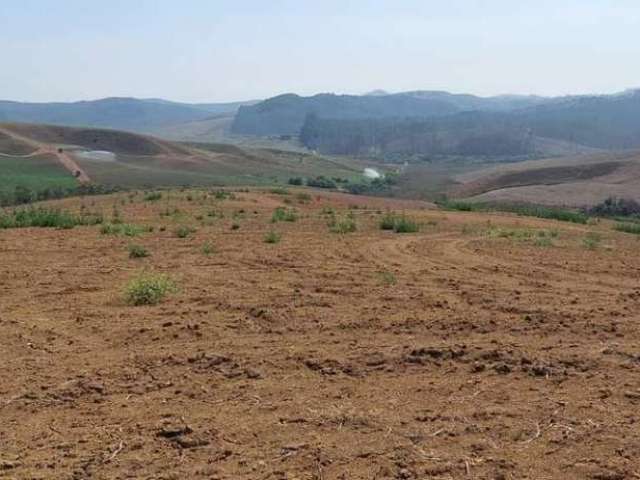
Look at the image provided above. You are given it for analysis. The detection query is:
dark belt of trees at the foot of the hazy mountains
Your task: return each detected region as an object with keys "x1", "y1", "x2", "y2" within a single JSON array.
[{"x1": 300, "y1": 113, "x2": 535, "y2": 157}]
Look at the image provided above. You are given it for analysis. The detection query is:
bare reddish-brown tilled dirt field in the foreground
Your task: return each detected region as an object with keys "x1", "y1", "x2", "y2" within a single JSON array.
[{"x1": 0, "y1": 191, "x2": 640, "y2": 480}]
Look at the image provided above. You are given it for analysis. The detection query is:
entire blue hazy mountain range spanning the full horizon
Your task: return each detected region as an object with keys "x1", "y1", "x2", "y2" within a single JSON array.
[{"x1": 0, "y1": 90, "x2": 640, "y2": 158}]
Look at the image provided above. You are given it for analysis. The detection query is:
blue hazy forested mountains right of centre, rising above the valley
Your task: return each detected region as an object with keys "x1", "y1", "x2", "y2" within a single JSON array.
[{"x1": 231, "y1": 90, "x2": 640, "y2": 156}]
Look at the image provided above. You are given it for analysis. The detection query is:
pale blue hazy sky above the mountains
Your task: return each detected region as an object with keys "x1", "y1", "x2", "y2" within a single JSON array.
[{"x1": 0, "y1": 0, "x2": 640, "y2": 102}]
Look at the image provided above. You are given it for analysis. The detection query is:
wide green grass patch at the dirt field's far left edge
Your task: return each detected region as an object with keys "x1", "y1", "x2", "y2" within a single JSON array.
[{"x1": 0, "y1": 207, "x2": 103, "y2": 229}]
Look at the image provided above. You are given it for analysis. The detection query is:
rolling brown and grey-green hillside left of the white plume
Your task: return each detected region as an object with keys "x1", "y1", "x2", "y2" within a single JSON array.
[{"x1": 0, "y1": 124, "x2": 376, "y2": 188}]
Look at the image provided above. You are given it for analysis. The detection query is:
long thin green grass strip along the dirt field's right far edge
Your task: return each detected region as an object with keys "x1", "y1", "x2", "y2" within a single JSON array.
[{"x1": 437, "y1": 200, "x2": 589, "y2": 225}]
